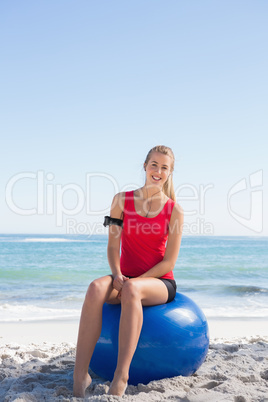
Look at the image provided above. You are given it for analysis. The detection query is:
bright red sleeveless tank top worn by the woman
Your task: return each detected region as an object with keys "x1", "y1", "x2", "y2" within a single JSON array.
[{"x1": 120, "y1": 190, "x2": 175, "y2": 279}]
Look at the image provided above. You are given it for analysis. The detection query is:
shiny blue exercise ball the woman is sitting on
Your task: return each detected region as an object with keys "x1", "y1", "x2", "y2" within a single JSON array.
[{"x1": 90, "y1": 293, "x2": 209, "y2": 385}]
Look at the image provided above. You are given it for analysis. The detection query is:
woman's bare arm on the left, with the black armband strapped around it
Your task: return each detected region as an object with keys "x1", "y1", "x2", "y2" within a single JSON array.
[{"x1": 107, "y1": 193, "x2": 126, "y2": 291}]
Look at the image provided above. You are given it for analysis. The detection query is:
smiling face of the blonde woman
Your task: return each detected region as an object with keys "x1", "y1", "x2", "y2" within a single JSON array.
[{"x1": 145, "y1": 152, "x2": 171, "y2": 187}]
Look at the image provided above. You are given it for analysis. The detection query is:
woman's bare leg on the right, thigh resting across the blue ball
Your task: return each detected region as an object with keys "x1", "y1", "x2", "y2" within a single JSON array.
[{"x1": 109, "y1": 278, "x2": 168, "y2": 396}]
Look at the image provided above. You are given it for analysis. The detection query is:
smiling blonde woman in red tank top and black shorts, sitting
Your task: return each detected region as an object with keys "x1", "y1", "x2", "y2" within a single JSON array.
[{"x1": 73, "y1": 145, "x2": 183, "y2": 397}]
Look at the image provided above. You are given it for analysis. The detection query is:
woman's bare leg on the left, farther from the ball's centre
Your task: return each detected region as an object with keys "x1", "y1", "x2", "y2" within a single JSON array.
[{"x1": 73, "y1": 276, "x2": 119, "y2": 397}]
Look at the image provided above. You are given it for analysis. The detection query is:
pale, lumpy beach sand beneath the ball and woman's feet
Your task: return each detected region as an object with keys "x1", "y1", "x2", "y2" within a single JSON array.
[{"x1": 0, "y1": 319, "x2": 268, "y2": 402}]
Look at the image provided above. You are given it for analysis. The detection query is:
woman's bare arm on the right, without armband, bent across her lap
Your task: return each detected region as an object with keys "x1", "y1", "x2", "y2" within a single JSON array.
[{"x1": 140, "y1": 204, "x2": 184, "y2": 278}]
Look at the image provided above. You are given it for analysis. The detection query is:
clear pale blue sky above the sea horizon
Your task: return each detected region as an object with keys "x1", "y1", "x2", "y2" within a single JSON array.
[{"x1": 0, "y1": 0, "x2": 268, "y2": 236}]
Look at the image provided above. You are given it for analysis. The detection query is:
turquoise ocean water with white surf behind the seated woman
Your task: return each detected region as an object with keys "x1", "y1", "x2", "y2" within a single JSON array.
[{"x1": 0, "y1": 235, "x2": 268, "y2": 322}]
